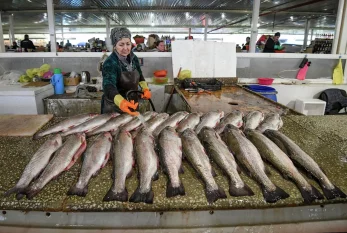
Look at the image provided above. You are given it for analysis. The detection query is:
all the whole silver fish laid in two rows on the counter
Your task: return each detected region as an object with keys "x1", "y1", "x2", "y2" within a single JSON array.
[{"x1": 5, "y1": 111, "x2": 346, "y2": 203}]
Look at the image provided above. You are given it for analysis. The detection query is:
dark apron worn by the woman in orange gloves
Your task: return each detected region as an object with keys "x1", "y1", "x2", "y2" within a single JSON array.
[{"x1": 101, "y1": 70, "x2": 140, "y2": 114}]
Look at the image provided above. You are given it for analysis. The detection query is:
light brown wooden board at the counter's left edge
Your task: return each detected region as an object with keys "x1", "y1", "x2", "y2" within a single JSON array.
[{"x1": 0, "y1": 114, "x2": 53, "y2": 136}]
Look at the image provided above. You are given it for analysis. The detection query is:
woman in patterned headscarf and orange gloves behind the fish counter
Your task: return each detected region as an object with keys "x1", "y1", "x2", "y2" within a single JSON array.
[{"x1": 101, "y1": 28, "x2": 151, "y2": 116}]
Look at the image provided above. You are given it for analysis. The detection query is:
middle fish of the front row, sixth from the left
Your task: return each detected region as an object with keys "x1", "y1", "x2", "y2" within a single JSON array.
[{"x1": 158, "y1": 126, "x2": 185, "y2": 197}]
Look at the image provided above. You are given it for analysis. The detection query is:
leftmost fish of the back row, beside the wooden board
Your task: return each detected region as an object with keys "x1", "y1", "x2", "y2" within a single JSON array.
[{"x1": 33, "y1": 113, "x2": 99, "y2": 140}]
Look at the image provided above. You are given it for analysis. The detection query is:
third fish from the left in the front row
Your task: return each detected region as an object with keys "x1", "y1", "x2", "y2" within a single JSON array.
[{"x1": 67, "y1": 132, "x2": 112, "y2": 197}]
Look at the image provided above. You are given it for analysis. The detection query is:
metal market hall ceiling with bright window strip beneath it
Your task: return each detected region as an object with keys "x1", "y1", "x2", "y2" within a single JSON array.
[{"x1": 0, "y1": 0, "x2": 338, "y2": 33}]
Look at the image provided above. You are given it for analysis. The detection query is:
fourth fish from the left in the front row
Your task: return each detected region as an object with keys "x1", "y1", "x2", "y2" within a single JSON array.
[{"x1": 103, "y1": 130, "x2": 135, "y2": 202}]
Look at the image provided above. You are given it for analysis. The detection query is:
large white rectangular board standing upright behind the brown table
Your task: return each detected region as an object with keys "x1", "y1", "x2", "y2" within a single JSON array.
[{"x1": 172, "y1": 40, "x2": 237, "y2": 78}]
